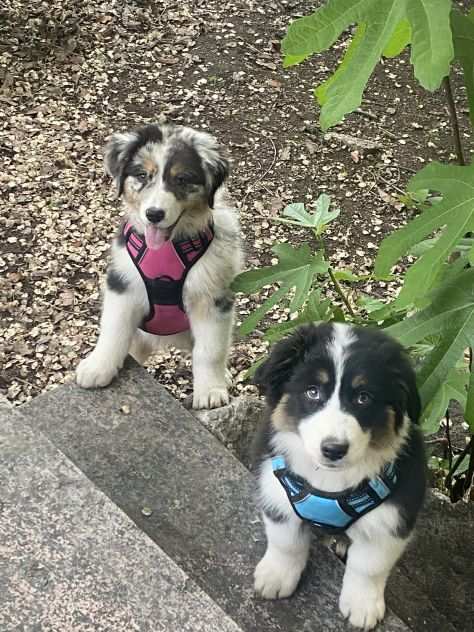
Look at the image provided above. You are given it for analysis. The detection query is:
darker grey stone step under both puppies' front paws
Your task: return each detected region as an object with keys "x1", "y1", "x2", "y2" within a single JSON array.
[{"x1": 21, "y1": 364, "x2": 409, "y2": 632}]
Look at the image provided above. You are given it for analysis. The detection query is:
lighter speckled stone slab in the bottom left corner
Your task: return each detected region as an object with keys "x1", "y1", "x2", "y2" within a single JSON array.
[{"x1": 0, "y1": 408, "x2": 240, "y2": 632}]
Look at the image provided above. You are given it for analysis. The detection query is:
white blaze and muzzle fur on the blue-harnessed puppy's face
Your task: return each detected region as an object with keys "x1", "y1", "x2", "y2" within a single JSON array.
[{"x1": 299, "y1": 323, "x2": 370, "y2": 466}]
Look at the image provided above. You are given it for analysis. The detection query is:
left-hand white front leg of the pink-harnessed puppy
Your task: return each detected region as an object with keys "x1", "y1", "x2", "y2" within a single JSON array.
[{"x1": 76, "y1": 271, "x2": 147, "y2": 388}]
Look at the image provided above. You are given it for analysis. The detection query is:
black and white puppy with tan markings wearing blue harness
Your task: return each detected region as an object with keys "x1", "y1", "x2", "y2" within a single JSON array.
[{"x1": 255, "y1": 323, "x2": 425, "y2": 630}]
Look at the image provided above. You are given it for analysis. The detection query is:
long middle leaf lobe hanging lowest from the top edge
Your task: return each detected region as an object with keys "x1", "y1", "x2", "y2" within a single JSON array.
[{"x1": 319, "y1": 0, "x2": 405, "y2": 130}]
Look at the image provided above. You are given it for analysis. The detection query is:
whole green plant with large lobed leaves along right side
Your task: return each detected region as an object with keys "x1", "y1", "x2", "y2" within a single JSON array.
[{"x1": 234, "y1": 0, "x2": 474, "y2": 504}]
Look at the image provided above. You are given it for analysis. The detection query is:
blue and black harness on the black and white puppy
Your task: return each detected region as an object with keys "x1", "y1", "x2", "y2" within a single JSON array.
[{"x1": 272, "y1": 456, "x2": 397, "y2": 533}]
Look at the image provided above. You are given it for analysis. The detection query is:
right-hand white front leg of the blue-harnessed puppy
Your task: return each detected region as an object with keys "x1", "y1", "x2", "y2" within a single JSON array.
[{"x1": 339, "y1": 535, "x2": 408, "y2": 630}]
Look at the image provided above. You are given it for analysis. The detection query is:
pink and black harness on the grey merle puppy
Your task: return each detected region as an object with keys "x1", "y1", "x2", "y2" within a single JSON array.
[{"x1": 123, "y1": 223, "x2": 214, "y2": 336}]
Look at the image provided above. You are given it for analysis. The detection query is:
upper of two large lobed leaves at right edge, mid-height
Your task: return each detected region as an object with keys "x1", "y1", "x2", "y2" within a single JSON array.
[{"x1": 375, "y1": 162, "x2": 474, "y2": 294}]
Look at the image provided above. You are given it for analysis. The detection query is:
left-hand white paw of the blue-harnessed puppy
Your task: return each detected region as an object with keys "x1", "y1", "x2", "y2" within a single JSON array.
[{"x1": 254, "y1": 553, "x2": 303, "y2": 599}]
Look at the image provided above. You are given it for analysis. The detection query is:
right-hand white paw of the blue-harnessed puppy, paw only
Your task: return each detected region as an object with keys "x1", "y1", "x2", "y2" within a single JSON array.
[{"x1": 339, "y1": 580, "x2": 385, "y2": 630}]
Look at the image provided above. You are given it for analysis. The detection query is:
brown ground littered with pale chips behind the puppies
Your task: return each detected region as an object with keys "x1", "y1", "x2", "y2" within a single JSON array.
[{"x1": 0, "y1": 0, "x2": 468, "y2": 403}]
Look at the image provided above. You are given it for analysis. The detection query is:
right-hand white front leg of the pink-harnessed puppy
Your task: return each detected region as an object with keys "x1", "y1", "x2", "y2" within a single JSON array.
[{"x1": 188, "y1": 305, "x2": 233, "y2": 408}]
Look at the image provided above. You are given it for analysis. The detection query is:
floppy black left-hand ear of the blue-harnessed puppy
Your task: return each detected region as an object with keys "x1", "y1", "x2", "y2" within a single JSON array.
[{"x1": 252, "y1": 325, "x2": 318, "y2": 405}]
